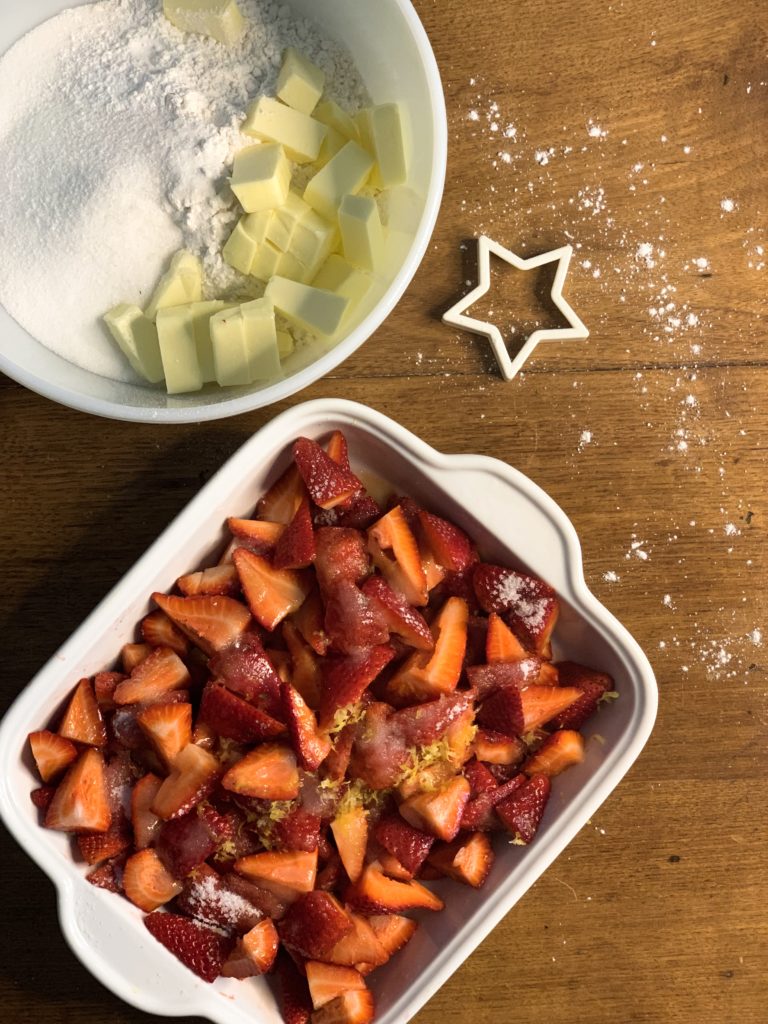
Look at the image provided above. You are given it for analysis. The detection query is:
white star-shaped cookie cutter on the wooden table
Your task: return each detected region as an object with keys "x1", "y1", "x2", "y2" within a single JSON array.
[{"x1": 442, "y1": 234, "x2": 590, "y2": 381}]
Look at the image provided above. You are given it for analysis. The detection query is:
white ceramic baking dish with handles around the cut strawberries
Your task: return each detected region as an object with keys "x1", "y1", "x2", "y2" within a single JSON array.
[{"x1": 0, "y1": 399, "x2": 657, "y2": 1024}]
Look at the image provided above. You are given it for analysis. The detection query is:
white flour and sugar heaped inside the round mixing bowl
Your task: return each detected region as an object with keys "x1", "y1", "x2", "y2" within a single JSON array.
[{"x1": 0, "y1": 0, "x2": 366, "y2": 380}]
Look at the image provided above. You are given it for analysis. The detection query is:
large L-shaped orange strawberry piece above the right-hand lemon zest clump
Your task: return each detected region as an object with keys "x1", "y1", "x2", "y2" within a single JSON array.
[{"x1": 387, "y1": 597, "x2": 469, "y2": 705}]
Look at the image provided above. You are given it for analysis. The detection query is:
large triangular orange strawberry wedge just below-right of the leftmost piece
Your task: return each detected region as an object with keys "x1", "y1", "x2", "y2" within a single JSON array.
[{"x1": 45, "y1": 746, "x2": 112, "y2": 833}]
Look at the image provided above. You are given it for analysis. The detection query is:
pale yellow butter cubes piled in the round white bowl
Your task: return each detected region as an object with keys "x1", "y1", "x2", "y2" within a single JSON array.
[{"x1": 104, "y1": 14, "x2": 415, "y2": 394}]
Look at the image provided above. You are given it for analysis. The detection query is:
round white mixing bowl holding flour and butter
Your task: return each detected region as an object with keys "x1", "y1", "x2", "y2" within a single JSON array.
[{"x1": 0, "y1": 0, "x2": 447, "y2": 423}]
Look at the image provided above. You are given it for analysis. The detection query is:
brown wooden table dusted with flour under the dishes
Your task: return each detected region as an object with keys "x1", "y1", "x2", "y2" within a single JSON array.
[{"x1": 0, "y1": 0, "x2": 768, "y2": 1024}]
